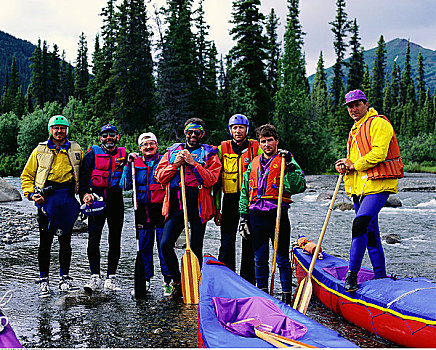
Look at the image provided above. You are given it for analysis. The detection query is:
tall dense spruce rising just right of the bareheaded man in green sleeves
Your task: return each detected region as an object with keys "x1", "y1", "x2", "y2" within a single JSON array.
[{"x1": 274, "y1": 0, "x2": 330, "y2": 173}]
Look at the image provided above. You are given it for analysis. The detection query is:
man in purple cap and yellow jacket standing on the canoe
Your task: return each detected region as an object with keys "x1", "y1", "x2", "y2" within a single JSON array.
[{"x1": 336, "y1": 90, "x2": 404, "y2": 292}]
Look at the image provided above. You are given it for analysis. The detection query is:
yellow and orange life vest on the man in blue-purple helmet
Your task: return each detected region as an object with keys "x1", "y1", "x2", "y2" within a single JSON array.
[{"x1": 221, "y1": 140, "x2": 259, "y2": 193}]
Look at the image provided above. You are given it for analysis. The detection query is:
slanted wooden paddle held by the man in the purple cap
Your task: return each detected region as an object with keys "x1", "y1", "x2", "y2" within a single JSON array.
[{"x1": 292, "y1": 174, "x2": 342, "y2": 314}]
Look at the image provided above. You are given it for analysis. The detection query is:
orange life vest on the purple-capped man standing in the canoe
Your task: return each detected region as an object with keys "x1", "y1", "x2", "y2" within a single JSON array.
[{"x1": 347, "y1": 115, "x2": 404, "y2": 180}]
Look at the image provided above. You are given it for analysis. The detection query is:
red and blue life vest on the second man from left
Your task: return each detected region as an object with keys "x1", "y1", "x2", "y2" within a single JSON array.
[{"x1": 91, "y1": 146, "x2": 127, "y2": 188}]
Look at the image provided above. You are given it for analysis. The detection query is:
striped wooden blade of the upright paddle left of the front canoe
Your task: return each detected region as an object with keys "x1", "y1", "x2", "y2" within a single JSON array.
[{"x1": 181, "y1": 249, "x2": 201, "y2": 304}]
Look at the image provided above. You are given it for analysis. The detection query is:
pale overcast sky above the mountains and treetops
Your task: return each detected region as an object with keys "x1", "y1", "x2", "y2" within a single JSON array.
[{"x1": 0, "y1": 0, "x2": 436, "y2": 74}]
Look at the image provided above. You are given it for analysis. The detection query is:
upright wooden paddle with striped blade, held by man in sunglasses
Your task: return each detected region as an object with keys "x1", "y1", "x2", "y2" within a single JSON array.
[{"x1": 180, "y1": 165, "x2": 201, "y2": 304}]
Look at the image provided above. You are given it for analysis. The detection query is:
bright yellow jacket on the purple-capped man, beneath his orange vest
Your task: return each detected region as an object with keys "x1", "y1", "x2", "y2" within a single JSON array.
[{"x1": 344, "y1": 108, "x2": 398, "y2": 196}]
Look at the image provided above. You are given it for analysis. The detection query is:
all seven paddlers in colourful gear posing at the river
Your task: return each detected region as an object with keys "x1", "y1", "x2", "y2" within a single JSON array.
[{"x1": 21, "y1": 90, "x2": 401, "y2": 304}]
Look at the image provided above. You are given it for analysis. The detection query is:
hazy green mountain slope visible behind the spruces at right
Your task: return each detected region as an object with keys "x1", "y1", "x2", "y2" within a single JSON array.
[{"x1": 308, "y1": 38, "x2": 436, "y2": 93}]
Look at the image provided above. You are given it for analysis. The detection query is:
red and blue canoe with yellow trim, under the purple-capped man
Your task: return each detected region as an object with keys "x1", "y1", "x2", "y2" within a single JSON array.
[{"x1": 293, "y1": 248, "x2": 436, "y2": 348}]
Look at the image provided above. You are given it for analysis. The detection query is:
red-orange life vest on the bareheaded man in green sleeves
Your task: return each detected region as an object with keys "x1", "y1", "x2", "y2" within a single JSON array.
[{"x1": 248, "y1": 155, "x2": 292, "y2": 203}]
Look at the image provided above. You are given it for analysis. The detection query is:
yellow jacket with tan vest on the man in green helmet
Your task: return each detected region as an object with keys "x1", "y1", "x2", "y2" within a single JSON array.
[{"x1": 21, "y1": 141, "x2": 83, "y2": 199}]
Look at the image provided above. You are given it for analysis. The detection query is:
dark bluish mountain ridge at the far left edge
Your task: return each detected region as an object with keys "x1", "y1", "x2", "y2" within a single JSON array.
[{"x1": 0, "y1": 30, "x2": 35, "y2": 93}]
